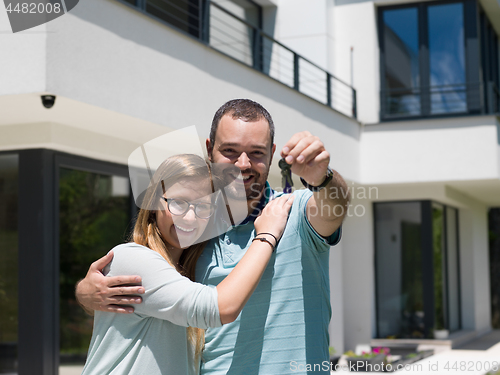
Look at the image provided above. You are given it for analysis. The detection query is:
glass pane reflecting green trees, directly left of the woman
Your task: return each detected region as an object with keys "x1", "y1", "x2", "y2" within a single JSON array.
[{"x1": 59, "y1": 167, "x2": 130, "y2": 375}]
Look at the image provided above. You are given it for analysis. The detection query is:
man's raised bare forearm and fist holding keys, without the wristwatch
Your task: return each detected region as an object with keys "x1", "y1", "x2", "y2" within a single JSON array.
[{"x1": 281, "y1": 131, "x2": 350, "y2": 237}]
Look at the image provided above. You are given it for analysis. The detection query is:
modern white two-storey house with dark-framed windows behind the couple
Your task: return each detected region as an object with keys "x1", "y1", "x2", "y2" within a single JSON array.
[{"x1": 0, "y1": 0, "x2": 500, "y2": 375}]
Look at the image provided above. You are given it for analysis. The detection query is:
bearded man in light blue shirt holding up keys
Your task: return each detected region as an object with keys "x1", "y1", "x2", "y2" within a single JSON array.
[{"x1": 77, "y1": 99, "x2": 349, "y2": 375}]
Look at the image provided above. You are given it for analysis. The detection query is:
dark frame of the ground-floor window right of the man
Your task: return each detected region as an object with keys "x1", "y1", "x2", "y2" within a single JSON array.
[{"x1": 372, "y1": 199, "x2": 463, "y2": 338}]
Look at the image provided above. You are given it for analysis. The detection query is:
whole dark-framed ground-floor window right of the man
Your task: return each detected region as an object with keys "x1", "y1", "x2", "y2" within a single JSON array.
[{"x1": 374, "y1": 201, "x2": 460, "y2": 338}]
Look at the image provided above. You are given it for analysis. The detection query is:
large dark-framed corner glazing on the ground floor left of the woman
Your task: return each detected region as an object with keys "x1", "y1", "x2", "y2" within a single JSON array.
[{"x1": 0, "y1": 149, "x2": 136, "y2": 375}]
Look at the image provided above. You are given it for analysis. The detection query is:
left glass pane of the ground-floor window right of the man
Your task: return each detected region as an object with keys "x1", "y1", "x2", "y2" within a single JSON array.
[{"x1": 375, "y1": 202, "x2": 425, "y2": 338}]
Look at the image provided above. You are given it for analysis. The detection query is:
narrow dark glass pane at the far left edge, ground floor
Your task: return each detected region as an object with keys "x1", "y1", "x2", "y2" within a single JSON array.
[{"x1": 0, "y1": 154, "x2": 19, "y2": 374}]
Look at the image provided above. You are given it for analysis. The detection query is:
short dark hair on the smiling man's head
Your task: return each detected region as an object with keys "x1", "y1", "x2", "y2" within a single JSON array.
[{"x1": 210, "y1": 99, "x2": 274, "y2": 153}]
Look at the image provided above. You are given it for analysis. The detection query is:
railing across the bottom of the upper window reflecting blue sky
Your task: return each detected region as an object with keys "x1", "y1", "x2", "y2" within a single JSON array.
[{"x1": 380, "y1": 82, "x2": 500, "y2": 120}]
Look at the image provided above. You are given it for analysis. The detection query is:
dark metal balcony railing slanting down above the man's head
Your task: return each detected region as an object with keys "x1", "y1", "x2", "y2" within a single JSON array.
[{"x1": 119, "y1": 0, "x2": 357, "y2": 118}]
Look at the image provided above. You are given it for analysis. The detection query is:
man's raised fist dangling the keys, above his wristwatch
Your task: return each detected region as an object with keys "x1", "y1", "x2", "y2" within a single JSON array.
[{"x1": 281, "y1": 131, "x2": 330, "y2": 186}]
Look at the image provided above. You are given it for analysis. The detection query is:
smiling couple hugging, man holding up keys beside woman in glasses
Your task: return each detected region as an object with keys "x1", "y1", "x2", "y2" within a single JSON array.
[{"x1": 76, "y1": 99, "x2": 349, "y2": 375}]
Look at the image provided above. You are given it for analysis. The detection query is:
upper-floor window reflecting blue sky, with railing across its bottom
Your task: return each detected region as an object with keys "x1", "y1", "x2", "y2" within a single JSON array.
[{"x1": 379, "y1": 0, "x2": 498, "y2": 120}]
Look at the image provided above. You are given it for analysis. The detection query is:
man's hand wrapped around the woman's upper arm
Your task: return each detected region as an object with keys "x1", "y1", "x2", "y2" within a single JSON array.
[{"x1": 75, "y1": 251, "x2": 144, "y2": 315}]
